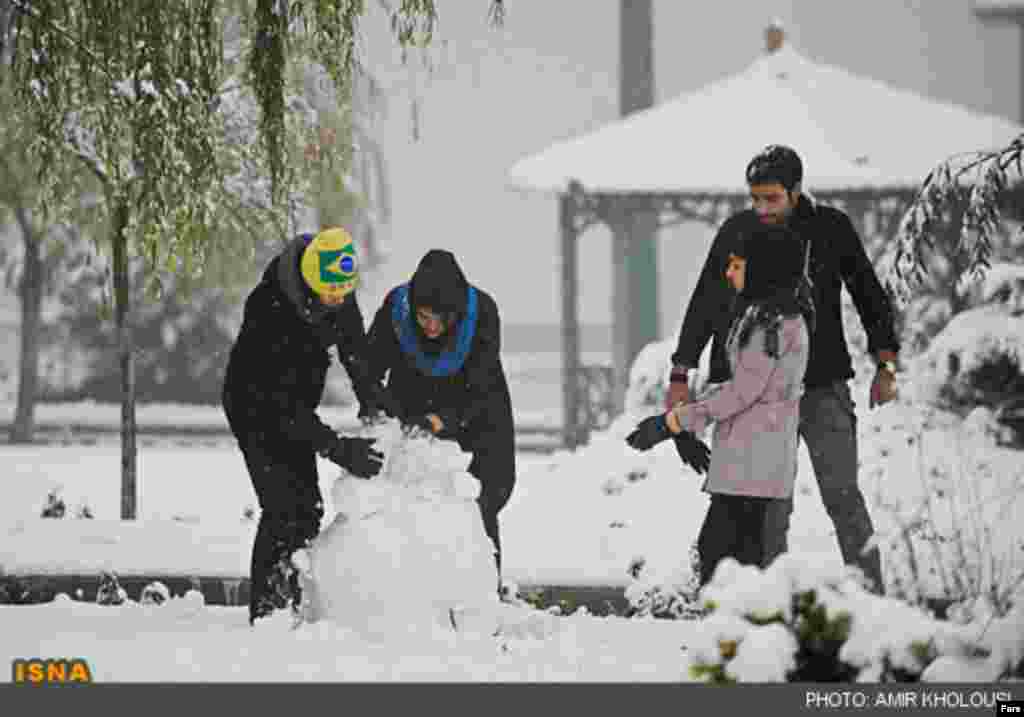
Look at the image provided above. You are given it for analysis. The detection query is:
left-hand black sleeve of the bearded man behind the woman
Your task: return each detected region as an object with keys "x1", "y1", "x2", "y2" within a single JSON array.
[{"x1": 672, "y1": 221, "x2": 735, "y2": 369}]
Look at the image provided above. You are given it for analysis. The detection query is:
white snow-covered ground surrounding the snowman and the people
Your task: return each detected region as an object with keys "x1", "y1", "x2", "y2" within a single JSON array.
[{"x1": 0, "y1": 358, "x2": 1024, "y2": 681}]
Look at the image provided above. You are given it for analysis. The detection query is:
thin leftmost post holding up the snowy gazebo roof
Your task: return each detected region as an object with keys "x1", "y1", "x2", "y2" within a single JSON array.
[{"x1": 558, "y1": 193, "x2": 583, "y2": 450}]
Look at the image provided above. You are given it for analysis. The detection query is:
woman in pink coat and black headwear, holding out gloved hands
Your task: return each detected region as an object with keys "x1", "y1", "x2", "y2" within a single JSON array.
[{"x1": 627, "y1": 226, "x2": 813, "y2": 587}]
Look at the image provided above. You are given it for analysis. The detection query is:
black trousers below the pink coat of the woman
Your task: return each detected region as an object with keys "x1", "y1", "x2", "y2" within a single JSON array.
[{"x1": 697, "y1": 493, "x2": 778, "y2": 588}]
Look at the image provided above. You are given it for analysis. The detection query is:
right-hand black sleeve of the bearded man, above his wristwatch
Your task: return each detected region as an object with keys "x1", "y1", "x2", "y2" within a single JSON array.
[{"x1": 835, "y1": 212, "x2": 899, "y2": 355}]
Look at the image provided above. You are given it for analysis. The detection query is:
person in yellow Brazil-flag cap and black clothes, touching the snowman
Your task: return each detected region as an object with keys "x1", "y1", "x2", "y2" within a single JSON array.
[{"x1": 222, "y1": 227, "x2": 383, "y2": 623}]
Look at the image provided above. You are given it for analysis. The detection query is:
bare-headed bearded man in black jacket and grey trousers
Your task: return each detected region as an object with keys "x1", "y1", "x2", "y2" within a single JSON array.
[{"x1": 667, "y1": 144, "x2": 899, "y2": 592}]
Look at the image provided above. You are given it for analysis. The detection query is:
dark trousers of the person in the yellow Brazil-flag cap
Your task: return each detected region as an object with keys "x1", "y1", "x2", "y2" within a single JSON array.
[{"x1": 239, "y1": 440, "x2": 324, "y2": 622}]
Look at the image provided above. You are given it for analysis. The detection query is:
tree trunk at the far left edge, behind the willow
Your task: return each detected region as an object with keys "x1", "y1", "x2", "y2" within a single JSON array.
[{"x1": 10, "y1": 207, "x2": 43, "y2": 444}]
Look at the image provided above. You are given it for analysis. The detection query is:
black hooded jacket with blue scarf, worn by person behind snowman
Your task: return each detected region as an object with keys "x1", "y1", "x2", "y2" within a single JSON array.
[{"x1": 366, "y1": 250, "x2": 515, "y2": 456}]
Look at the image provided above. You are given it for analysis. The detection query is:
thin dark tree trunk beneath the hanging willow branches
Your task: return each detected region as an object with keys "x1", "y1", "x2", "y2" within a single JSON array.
[{"x1": 111, "y1": 200, "x2": 138, "y2": 520}]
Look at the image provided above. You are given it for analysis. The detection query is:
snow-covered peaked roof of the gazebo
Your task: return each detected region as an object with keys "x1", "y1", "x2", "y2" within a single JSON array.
[{"x1": 509, "y1": 27, "x2": 1024, "y2": 195}]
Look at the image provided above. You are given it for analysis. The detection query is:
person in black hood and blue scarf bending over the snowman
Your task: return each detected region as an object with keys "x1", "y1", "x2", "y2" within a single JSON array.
[{"x1": 361, "y1": 249, "x2": 516, "y2": 586}]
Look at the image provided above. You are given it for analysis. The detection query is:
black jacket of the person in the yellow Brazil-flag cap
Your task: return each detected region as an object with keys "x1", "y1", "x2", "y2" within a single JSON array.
[{"x1": 222, "y1": 238, "x2": 376, "y2": 451}]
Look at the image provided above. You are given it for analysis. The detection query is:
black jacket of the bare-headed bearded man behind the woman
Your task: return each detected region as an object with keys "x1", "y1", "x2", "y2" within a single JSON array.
[{"x1": 672, "y1": 196, "x2": 899, "y2": 388}]
